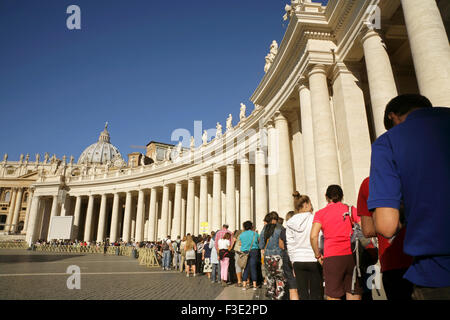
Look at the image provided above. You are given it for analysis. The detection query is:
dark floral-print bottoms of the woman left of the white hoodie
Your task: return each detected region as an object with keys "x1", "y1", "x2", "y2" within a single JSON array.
[{"x1": 264, "y1": 255, "x2": 286, "y2": 300}]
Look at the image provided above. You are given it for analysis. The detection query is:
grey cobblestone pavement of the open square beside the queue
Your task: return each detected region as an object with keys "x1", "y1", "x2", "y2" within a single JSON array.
[{"x1": 0, "y1": 250, "x2": 246, "y2": 300}]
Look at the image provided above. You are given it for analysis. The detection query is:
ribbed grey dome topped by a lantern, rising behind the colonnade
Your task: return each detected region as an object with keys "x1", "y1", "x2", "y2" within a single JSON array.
[{"x1": 78, "y1": 123, "x2": 124, "y2": 167}]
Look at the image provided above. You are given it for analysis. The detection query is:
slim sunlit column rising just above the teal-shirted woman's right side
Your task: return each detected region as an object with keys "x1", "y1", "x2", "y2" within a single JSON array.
[{"x1": 255, "y1": 148, "x2": 268, "y2": 232}]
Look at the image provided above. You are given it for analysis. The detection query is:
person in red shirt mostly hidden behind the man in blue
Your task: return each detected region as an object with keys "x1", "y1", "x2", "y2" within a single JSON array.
[{"x1": 358, "y1": 178, "x2": 413, "y2": 300}]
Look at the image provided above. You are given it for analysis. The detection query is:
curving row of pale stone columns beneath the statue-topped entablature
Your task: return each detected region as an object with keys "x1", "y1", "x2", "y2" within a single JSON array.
[{"x1": 25, "y1": 0, "x2": 450, "y2": 242}]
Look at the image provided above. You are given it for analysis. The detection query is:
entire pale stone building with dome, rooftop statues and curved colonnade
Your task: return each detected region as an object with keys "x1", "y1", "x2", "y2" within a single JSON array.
[{"x1": 0, "y1": 0, "x2": 450, "y2": 243}]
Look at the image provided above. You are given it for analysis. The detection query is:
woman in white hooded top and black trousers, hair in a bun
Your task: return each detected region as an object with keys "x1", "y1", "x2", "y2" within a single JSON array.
[{"x1": 286, "y1": 192, "x2": 323, "y2": 300}]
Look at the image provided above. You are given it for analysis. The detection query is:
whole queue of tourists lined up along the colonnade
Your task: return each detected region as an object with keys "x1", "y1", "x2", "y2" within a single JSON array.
[{"x1": 29, "y1": 95, "x2": 450, "y2": 300}]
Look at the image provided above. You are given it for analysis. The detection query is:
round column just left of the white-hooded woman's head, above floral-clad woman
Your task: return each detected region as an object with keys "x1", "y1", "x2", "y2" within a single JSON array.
[{"x1": 275, "y1": 112, "x2": 294, "y2": 216}]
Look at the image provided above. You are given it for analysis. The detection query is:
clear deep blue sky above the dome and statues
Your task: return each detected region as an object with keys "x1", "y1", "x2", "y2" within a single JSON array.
[{"x1": 0, "y1": 0, "x2": 326, "y2": 161}]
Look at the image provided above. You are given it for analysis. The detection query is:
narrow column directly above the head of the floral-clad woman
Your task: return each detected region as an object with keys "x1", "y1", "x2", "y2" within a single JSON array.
[{"x1": 267, "y1": 121, "x2": 279, "y2": 212}]
